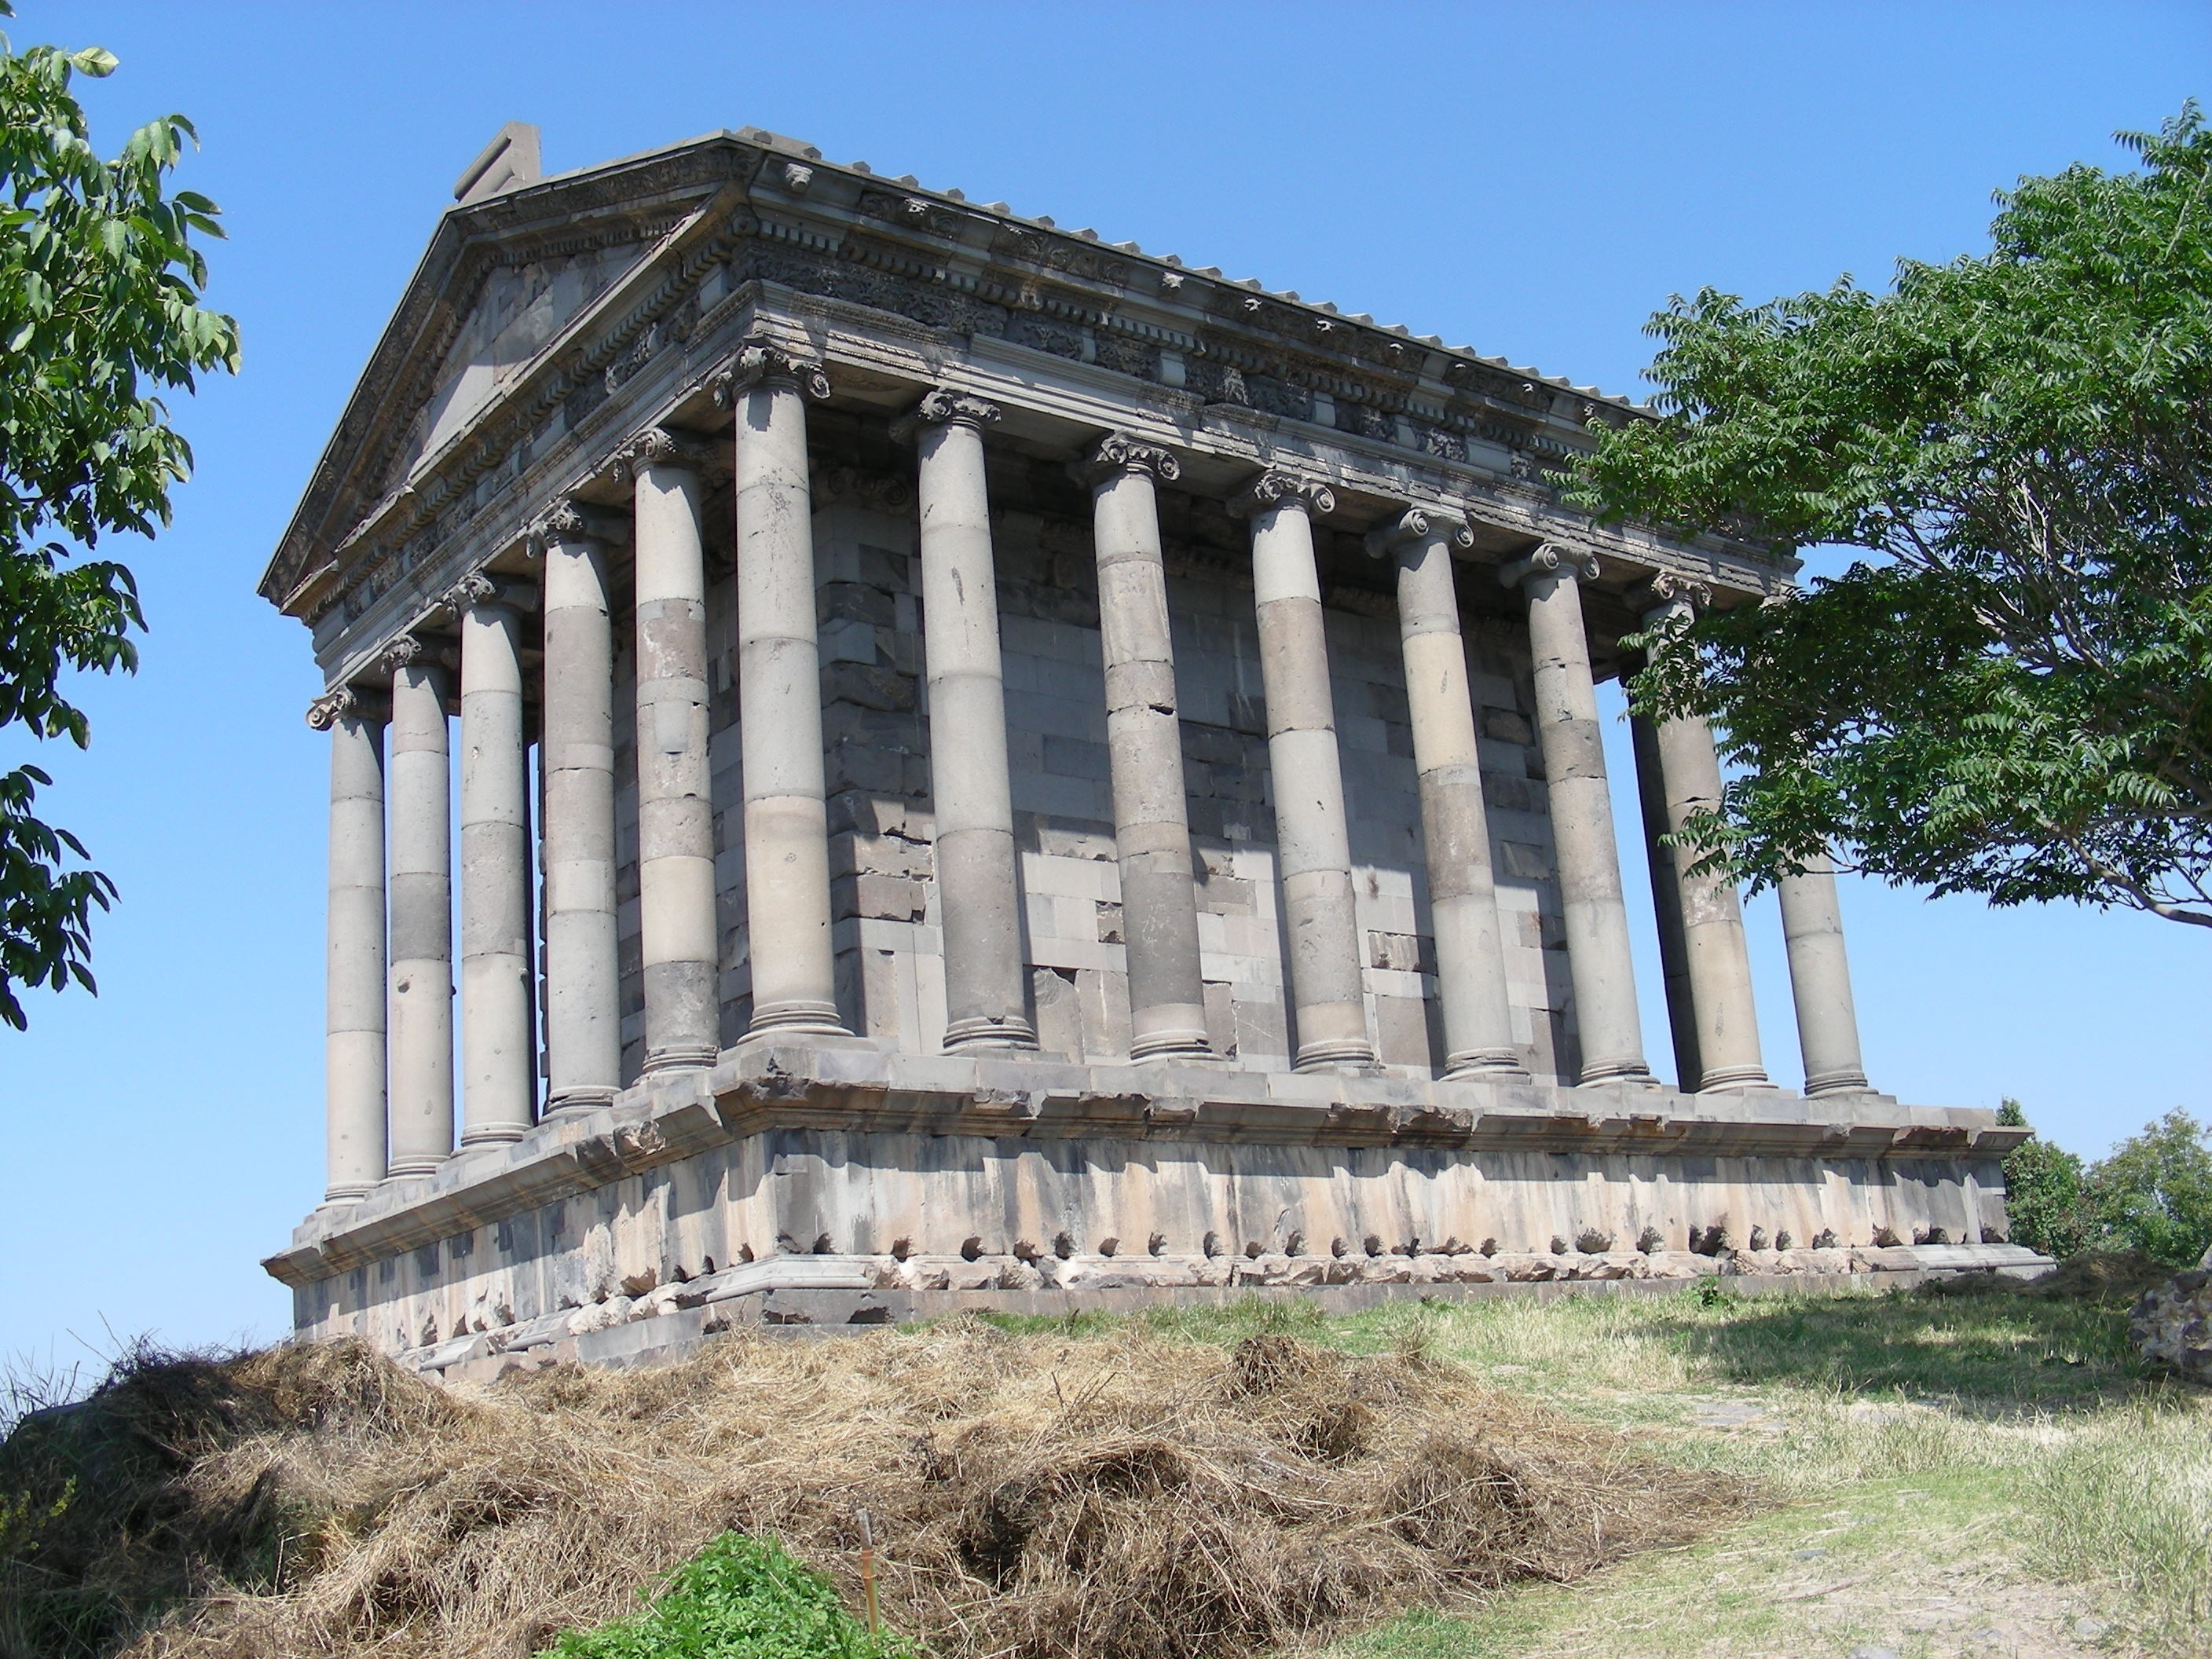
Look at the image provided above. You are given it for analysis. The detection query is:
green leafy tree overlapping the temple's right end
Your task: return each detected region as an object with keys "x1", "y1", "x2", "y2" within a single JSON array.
[{"x1": 1566, "y1": 104, "x2": 2212, "y2": 925}]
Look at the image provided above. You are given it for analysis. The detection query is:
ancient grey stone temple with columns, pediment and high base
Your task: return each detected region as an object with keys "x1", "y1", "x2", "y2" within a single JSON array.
[{"x1": 261, "y1": 128, "x2": 2033, "y2": 1369}]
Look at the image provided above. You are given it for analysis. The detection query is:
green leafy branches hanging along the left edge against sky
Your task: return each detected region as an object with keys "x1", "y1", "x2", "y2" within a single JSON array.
[{"x1": 0, "y1": 0, "x2": 239, "y2": 1028}]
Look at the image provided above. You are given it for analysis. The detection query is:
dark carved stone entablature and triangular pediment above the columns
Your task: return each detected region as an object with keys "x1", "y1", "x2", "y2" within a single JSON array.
[{"x1": 261, "y1": 128, "x2": 1789, "y2": 661}]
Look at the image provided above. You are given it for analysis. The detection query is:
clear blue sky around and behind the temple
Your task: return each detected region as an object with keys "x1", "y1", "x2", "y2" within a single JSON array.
[{"x1": 0, "y1": 0, "x2": 2212, "y2": 1363}]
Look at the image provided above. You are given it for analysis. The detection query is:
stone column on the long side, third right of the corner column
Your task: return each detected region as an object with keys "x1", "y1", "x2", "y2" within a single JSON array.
[{"x1": 1230, "y1": 469, "x2": 1376, "y2": 1068}]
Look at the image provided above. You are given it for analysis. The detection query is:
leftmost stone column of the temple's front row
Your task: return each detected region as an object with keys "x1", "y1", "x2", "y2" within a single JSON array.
[{"x1": 307, "y1": 686, "x2": 391, "y2": 1203}]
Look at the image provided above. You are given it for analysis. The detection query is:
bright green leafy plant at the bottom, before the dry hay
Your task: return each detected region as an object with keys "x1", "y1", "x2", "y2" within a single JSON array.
[{"x1": 547, "y1": 1533, "x2": 911, "y2": 1659}]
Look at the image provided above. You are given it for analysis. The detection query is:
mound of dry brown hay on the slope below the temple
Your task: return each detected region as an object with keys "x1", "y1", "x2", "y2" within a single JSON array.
[{"x1": 0, "y1": 1320, "x2": 1749, "y2": 1659}]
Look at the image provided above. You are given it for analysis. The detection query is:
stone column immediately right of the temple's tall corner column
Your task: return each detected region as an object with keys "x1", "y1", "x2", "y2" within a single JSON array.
[{"x1": 914, "y1": 390, "x2": 1038, "y2": 1049}]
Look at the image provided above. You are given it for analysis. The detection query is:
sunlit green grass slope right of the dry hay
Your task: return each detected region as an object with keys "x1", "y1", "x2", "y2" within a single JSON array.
[{"x1": 969, "y1": 1292, "x2": 2212, "y2": 1659}]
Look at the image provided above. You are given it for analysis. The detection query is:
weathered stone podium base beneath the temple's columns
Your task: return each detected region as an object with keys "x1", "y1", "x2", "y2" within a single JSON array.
[{"x1": 266, "y1": 1040, "x2": 2049, "y2": 1374}]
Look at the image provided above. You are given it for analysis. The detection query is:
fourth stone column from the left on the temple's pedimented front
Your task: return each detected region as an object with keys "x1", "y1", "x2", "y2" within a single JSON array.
[{"x1": 533, "y1": 502, "x2": 621, "y2": 1112}]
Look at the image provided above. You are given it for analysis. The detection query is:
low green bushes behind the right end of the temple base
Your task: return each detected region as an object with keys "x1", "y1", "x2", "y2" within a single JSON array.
[{"x1": 1998, "y1": 1100, "x2": 2212, "y2": 1268}]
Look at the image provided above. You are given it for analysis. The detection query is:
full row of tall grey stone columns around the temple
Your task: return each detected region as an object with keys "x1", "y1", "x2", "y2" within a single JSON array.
[{"x1": 309, "y1": 339, "x2": 1867, "y2": 1201}]
